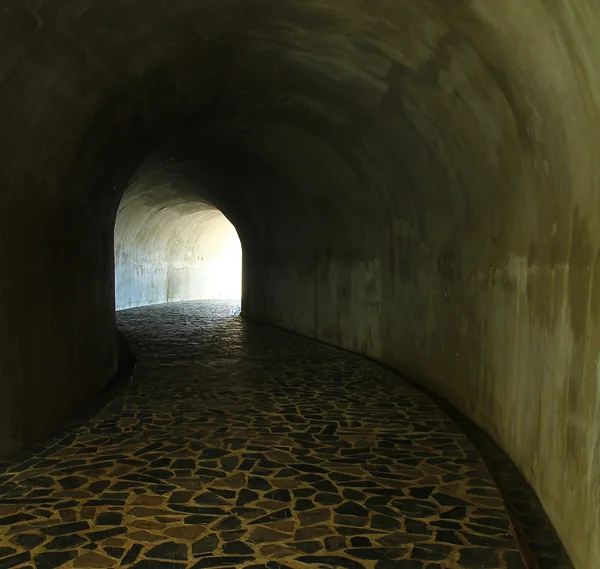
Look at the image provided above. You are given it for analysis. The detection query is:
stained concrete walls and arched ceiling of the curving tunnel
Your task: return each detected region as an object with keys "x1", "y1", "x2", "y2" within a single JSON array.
[{"x1": 0, "y1": 0, "x2": 600, "y2": 569}]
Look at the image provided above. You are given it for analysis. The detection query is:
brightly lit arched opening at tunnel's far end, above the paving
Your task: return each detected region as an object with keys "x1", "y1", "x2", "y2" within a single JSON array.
[{"x1": 114, "y1": 176, "x2": 242, "y2": 310}]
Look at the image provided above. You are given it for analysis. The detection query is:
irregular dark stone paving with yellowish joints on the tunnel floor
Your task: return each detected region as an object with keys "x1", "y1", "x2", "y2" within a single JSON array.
[{"x1": 0, "y1": 302, "x2": 525, "y2": 569}]
